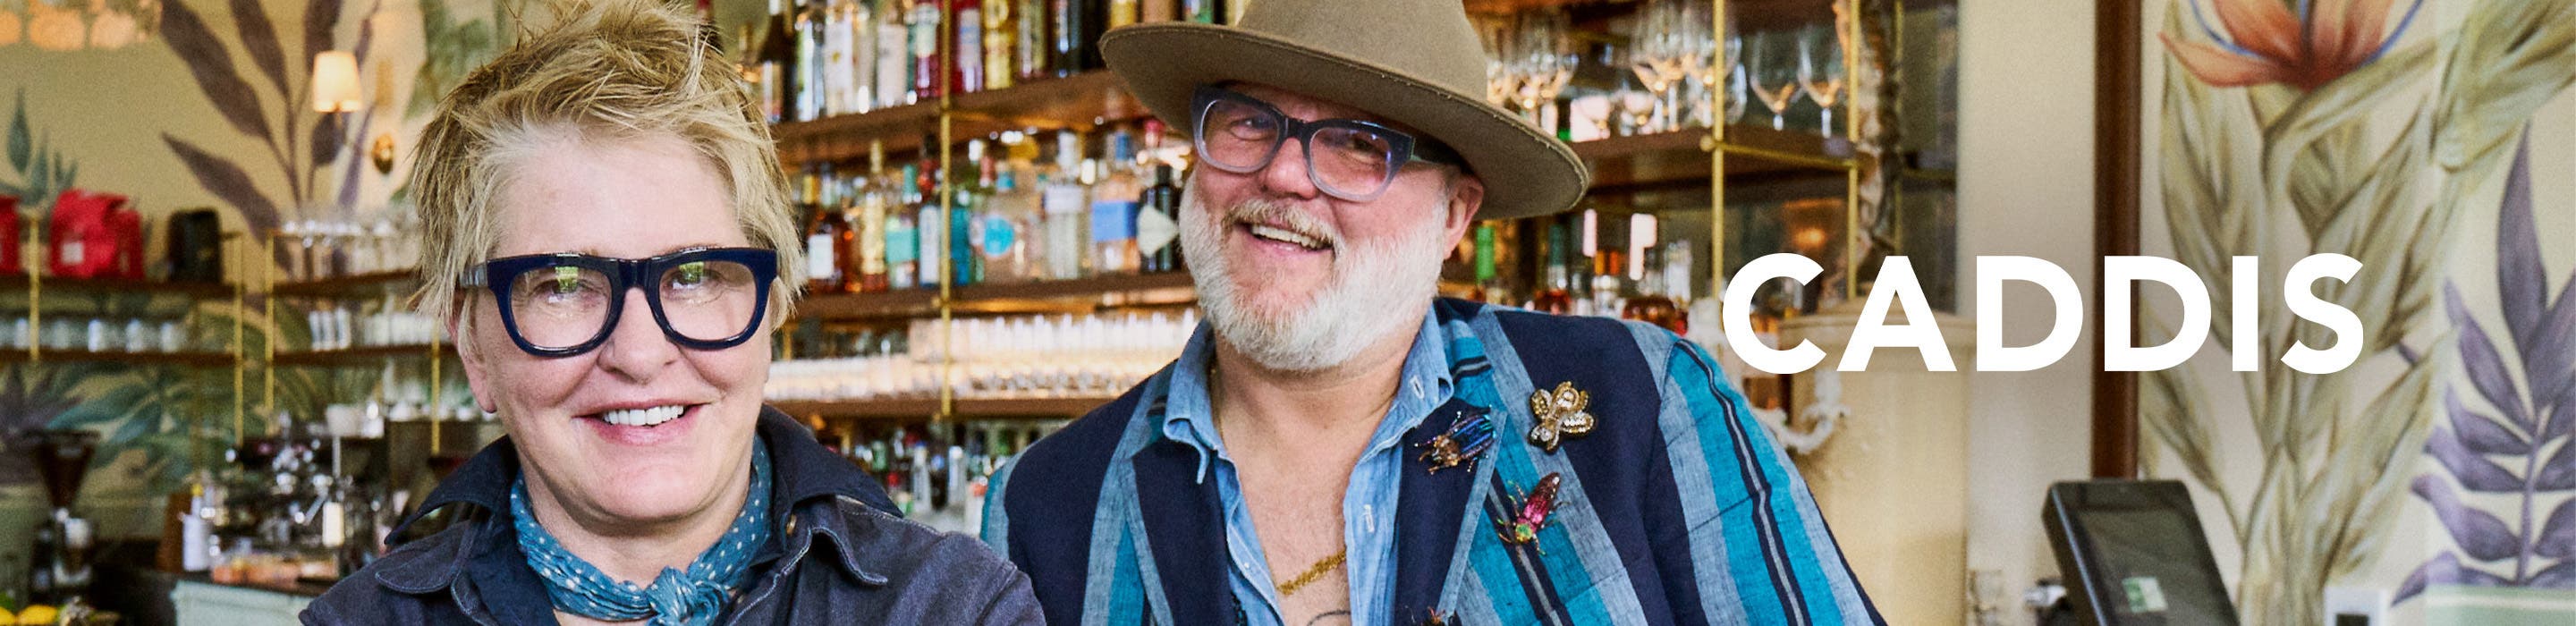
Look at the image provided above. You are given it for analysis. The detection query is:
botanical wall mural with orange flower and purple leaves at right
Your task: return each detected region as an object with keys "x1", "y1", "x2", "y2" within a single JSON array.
[{"x1": 2138, "y1": 0, "x2": 2576, "y2": 623}]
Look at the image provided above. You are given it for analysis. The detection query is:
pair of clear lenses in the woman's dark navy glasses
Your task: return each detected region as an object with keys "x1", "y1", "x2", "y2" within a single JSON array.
[{"x1": 510, "y1": 260, "x2": 760, "y2": 348}]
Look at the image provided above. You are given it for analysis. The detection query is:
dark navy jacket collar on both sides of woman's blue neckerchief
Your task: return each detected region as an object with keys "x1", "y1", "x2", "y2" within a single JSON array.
[{"x1": 376, "y1": 407, "x2": 896, "y2": 593}]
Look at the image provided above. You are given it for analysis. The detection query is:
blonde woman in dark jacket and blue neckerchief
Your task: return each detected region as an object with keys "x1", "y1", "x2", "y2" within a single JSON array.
[{"x1": 304, "y1": 0, "x2": 1038, "y2": 626}]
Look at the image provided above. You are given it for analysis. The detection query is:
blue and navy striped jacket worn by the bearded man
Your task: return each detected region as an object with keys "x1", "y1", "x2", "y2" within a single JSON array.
[{"x1": 984, "y1": 299, "x2": 1883, "y2": 626}]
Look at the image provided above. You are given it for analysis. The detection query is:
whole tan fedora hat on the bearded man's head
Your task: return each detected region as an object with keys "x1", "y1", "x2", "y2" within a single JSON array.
[{"x1": 1100, "y1": 0, "x2": 1592, "y2": 219}]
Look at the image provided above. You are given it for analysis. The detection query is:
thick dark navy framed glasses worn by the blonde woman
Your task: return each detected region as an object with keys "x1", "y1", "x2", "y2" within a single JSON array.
[{"x1": 463, "y1": 248, "x2": 778, "y2": 356}]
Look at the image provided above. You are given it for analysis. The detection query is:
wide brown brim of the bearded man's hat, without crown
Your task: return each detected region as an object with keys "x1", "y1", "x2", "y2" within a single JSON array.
[{"x1": 1100, "y1": 23, "x2": 1592, "y2": 219}]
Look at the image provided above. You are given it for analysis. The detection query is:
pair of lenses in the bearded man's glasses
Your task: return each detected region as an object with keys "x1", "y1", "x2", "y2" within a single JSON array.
[{"x1": 1198, "y1": 97, "x2": 1396, "y2": 199}]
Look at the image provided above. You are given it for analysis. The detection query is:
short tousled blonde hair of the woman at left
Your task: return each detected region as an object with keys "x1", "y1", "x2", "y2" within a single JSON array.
[{"x1": 412, "y1": 0, "x2": 804, "y2": 322}]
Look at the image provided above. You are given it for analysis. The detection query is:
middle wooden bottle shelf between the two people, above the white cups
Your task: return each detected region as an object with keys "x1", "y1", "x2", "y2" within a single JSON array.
[{"x1": 796, "y1": 270, "x2": 1198, "y2": 319}]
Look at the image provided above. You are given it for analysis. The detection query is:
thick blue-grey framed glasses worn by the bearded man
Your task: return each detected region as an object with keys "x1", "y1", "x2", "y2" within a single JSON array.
[{"x1": 1191, "y1": 85, "x2": 1463, "y2": 201}]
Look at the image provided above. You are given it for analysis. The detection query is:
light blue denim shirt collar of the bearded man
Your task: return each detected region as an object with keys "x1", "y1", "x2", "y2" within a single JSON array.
[{"x1": 1159, "y1": 312, "x2": 1458, "y2": 482}]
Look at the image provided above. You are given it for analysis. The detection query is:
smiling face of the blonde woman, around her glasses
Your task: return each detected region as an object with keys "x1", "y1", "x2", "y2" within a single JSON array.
[{"x1": 459, "y1": 131, "x2": 770, "y2": 530}]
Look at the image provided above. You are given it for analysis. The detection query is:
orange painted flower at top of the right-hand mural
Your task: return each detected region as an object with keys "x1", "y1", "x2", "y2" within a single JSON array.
[{"x1": 2157, "y1": 0, "x2": 2424, "y2": 90}]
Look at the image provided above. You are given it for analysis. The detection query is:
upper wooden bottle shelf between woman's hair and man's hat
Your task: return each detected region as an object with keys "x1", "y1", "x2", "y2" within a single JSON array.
[{"x1": 770, "y1": 70, "x2": 1151, "y2": 167}]
